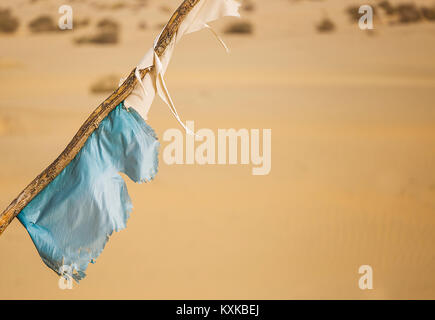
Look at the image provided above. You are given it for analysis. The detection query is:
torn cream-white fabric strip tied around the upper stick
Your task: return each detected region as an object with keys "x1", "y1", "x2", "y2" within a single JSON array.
[{"x1": 124, "y1": 0, "x2": 240, "y2": 133}]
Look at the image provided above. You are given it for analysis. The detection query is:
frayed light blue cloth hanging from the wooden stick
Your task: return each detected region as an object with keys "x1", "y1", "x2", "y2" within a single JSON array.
[{"x1": 18, "y1": 103, "x2": 159, "y2": 281}]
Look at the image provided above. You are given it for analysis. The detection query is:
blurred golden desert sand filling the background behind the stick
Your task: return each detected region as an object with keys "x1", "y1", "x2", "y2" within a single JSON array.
[{"x1": 0, "y1": 0, "x2": 435, "y2": 299}]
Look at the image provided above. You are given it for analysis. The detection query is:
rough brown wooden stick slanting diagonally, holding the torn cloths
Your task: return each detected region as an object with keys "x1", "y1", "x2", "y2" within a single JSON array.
[{"x1": 0, "y1": 0, "x2": 200, "y2": 235}]
